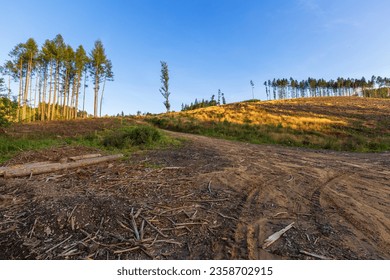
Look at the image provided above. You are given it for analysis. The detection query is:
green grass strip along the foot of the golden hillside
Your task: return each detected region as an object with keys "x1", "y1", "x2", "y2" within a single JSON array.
[{"x1": 148, "y1": 116, "x2": 390, "y2": 152}]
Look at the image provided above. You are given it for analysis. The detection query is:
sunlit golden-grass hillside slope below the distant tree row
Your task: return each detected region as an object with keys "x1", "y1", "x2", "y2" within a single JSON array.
[{"x1": 149, "y1": 97, "x2": 390, "y2": 152}]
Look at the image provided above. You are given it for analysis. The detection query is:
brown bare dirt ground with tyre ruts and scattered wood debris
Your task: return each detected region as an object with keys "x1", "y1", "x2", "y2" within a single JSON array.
[{"x1": 0, "y1": 130, "x2": 390, "y2": 259}]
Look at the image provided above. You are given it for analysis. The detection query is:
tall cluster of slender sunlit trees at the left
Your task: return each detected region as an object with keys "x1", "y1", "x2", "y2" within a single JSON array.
[{"x1": 0, "y1": 34, "x2": 114, "y2": 122}]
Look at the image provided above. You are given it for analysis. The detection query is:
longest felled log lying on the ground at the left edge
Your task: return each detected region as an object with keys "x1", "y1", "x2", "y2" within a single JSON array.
[{"x1": 0, "y1": 154, "x2": 123, "y2": 178}]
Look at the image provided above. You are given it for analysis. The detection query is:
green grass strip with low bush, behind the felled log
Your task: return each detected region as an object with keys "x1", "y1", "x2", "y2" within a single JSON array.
[{"x1": 0, "y1": 120, "x2": 181, "y2": 163}]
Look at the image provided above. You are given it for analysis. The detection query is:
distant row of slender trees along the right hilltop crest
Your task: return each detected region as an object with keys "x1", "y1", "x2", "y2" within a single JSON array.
[{"x1": 262, "y1": 76, "x2": 390, "y2": 99}]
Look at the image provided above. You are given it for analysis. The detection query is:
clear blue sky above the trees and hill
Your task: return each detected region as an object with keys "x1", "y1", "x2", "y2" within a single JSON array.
[{"x1": 0, "y1": 0, "x2": 390, "y2": 115}]
